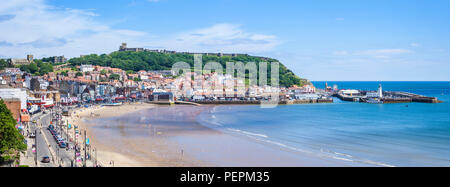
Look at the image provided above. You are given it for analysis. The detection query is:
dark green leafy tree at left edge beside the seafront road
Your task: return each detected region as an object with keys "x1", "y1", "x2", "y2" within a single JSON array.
[{"x1": 0, "y1": 100, "x2": 27, "y2": 163}]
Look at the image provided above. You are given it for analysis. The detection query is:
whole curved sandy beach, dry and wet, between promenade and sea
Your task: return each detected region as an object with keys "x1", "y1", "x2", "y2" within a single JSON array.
[{"x1": 66, "y1": 104, "x2": 361, "y2": 167}]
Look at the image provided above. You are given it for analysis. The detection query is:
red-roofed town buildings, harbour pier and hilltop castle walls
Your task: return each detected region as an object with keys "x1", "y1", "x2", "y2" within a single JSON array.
[{"x1": 0, "y1": 43, "x2": 438, "y2": 122}]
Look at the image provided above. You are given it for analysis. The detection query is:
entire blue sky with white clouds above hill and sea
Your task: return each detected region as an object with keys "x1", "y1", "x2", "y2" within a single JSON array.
[{"x1": 0, "y1": 0, "x2": 450, "y2": 81}]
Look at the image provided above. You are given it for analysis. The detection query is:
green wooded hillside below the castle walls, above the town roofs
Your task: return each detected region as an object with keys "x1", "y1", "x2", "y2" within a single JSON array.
[{"x1": 69, "y1": 51, "x2": 308, "y2": 87}]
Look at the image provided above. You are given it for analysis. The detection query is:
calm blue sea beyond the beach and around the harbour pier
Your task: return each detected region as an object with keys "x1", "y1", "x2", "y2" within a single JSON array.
[{"x1": 198, "y1": 82, "x2": 450, "y2": 166}]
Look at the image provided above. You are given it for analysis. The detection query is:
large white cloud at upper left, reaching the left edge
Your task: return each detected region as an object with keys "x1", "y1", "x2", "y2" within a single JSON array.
[{"x1": 0, "y1": 0, "x2": 151, "y2": 57}]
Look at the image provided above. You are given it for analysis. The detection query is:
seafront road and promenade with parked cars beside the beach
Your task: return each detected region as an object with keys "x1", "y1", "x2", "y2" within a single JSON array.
[{"x1": 19, "y1": 106, "x2": 100, "y2": 167}]
